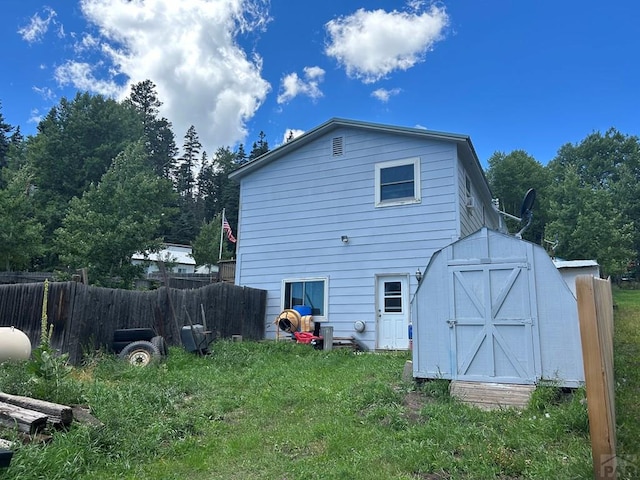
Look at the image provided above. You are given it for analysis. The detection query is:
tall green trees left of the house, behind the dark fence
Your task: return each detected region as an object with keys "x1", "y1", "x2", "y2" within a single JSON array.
[{"x1": 0, "y1": 80, "x2": 269, "y2": 288}]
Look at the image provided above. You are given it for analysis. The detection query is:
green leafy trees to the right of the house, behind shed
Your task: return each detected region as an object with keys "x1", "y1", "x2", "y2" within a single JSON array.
[{"x1": 486, "y1": 128, "x2": 640, "y2": 277}]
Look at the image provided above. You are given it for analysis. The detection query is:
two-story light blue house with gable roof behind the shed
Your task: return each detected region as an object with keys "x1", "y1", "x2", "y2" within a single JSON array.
[{"x1": 230, "y1": 119, "x2": 501, "y2": 350}]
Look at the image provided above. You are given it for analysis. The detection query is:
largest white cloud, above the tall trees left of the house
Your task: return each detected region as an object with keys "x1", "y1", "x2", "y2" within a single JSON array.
[{"x1": 56, "y1": 0, "x2": 271, "y2": 151}]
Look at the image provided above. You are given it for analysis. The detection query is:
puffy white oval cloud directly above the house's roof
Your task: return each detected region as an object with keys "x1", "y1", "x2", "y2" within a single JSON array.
[{"x1": 325, "y1": 1, "x2": 449, "y2": 83}]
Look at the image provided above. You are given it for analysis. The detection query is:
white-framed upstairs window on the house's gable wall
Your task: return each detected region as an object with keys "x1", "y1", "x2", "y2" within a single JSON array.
[{"x1": 376, "y1": 158, "x2": 420, "y2": 207}]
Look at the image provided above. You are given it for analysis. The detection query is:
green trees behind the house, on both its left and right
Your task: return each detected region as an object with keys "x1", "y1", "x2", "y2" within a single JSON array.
[{"x1": 0, "y1": 80, "x2": 640, "y2": 288}]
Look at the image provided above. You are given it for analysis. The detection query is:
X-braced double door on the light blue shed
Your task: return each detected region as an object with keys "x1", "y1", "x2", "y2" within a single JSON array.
[{"x1": 447, "y1": 261, "x2": 541, "y2": 384}]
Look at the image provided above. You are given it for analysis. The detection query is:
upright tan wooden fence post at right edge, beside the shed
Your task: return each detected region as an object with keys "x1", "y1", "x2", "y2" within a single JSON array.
[{"x1": 576, "y1": 275, "x2": 616, "y2": 479}]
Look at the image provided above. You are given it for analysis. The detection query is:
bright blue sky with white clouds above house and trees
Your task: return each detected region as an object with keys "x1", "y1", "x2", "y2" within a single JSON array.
[{"x1": 0, "y1": 0, "x2": 640, "y2": 167}]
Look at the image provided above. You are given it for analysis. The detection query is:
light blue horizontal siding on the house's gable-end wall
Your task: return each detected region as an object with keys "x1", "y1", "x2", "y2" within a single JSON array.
[{"x1": 236, "y1": 128, "x2": 470, "y2": 348}]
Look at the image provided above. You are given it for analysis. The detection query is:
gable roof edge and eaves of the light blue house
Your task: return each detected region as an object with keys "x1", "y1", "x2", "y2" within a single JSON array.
[{"x1": 229, "y1": 118, "x2": 482, "y2": 179}]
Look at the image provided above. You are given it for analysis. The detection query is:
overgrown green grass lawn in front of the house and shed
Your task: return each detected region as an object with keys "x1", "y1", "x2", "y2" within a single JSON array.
[{"x1": 0, "y1": 290, "x2": 640, "y2": 480}]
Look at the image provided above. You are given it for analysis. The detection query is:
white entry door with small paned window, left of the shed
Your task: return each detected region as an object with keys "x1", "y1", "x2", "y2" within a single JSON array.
[{"x1": 376, "y1": 275, "x2": 409, "y2": 350}]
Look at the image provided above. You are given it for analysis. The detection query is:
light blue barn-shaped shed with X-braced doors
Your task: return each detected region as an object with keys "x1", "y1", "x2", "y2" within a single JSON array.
[{"x1": 412, "y1": 228, "x2": 584, "y2": 387}]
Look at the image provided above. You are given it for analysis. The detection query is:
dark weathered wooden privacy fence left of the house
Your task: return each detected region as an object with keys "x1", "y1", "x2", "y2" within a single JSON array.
[{"x1": 0, "y1": 282, "x2": 266, "y2": 364}]
